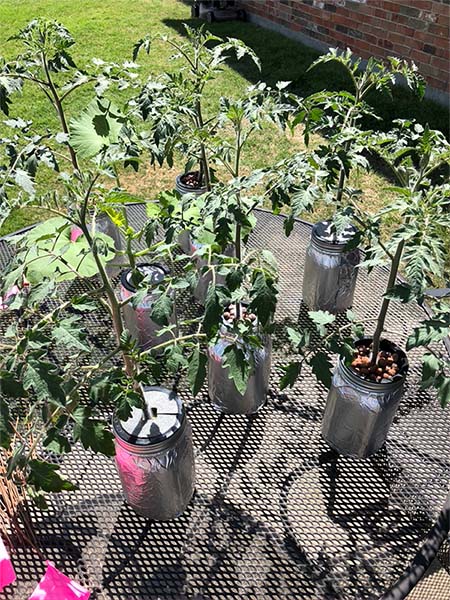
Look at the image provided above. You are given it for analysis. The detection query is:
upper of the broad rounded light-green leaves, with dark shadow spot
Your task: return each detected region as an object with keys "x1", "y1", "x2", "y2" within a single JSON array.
[{"x1": 70, "y1": 99, "x2": 125, "y2": 158}]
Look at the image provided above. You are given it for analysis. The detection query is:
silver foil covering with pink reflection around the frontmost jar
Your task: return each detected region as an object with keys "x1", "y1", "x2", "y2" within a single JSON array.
[{"x1": 116, "y1": 419, "x2": 195, "y2": 521}]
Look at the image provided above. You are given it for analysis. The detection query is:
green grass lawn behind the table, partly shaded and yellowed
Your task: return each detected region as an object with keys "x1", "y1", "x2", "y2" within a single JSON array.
[{"x1": 0, "y1": 0, "x2": 449, "y2": 250}]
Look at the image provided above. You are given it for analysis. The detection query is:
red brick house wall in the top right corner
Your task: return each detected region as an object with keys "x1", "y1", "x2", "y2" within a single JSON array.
[{"x1": 240, "y1": 0, "x2": 450, "y2": 93}]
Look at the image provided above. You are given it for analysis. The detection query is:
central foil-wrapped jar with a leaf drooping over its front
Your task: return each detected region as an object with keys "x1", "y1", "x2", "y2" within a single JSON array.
[{"x1": 208, "y1": 327, "x2": 272, "y2": 415}]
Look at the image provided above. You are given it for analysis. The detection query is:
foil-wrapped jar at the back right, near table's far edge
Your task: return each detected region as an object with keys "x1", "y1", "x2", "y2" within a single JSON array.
[{"x1": 302, "y1": 221, "x2": 360, "y2": 314}]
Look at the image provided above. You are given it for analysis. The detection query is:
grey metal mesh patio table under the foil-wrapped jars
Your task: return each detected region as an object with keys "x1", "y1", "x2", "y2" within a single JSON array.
[{"x1": 0, "y1": 205, "x2": 450, "y2": 600}]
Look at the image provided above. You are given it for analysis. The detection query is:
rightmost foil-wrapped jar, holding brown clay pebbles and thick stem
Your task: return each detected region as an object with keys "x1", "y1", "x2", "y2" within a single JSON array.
[{"x1": 322, "y1": 340, "x2": 408, "y2": 458}]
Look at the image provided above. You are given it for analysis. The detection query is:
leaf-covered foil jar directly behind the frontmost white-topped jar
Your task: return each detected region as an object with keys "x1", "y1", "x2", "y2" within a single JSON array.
[{"x1": 120, "y1": 263, "x2": 175, "y2": 350}]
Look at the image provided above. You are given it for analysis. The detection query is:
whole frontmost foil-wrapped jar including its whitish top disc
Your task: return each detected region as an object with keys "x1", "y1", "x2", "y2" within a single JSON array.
[{"x1": 113, "y1": 386, "x2": 195, "y2": 521}]
